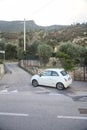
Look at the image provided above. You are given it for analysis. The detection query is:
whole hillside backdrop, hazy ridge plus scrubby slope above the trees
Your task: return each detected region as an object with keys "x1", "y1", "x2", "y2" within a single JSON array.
[{"x1": 0, "y1": 21, "x2": 87, "y2": 46}]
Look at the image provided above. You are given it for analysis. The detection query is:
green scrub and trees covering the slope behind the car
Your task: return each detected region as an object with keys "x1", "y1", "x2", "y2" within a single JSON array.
[{"x1": 0, "y1": 21, "x2": 87, "y2": 70}]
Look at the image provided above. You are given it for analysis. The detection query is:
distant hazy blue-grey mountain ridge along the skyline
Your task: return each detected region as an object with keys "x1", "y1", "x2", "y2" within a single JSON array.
[{"x1": 0, "y1": 20, "x2": 66, "y2": 32}]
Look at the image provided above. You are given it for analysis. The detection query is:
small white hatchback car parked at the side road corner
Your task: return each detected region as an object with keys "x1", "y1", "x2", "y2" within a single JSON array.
[{"x1": 31, "y1": 68, "x2": 72, "y2": 90}]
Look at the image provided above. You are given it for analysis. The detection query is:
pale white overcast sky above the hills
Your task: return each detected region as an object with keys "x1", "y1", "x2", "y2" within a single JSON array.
[{"x1": 0, "y1": 0, "x2": 87, "y2": 26}]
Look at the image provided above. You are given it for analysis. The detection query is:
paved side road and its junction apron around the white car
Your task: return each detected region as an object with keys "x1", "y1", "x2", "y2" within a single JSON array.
[{"x1": 0, "y1": 63, "x2": 87, "y2": 97}]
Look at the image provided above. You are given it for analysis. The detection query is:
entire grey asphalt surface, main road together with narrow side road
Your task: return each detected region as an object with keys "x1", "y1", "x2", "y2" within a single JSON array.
[{"x1": 0, "y1": 63, "x2": 87, "y2": 130}]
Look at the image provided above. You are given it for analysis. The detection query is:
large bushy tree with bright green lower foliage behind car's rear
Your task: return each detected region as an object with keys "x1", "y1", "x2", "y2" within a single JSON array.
[{"x1": 56, "y1": 42, "x2": 81, "y2": 70}]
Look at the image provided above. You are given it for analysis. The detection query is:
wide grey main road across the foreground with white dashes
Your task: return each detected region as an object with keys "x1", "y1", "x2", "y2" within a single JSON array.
[{"x1": 0, "y1": 93, "x2": 87, "y2": 130}]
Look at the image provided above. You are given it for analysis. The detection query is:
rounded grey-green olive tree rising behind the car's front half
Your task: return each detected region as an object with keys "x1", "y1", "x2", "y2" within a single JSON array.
[{"x1": 38, "y1": 44, "x2": 53, "y2": 66}]
